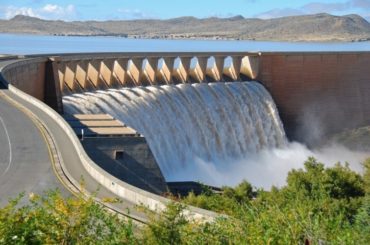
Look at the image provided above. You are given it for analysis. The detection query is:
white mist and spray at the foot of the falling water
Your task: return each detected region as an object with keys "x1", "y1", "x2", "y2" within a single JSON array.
[{"x1": 166, "y1": 142, "x2": 369, "y2": 190}]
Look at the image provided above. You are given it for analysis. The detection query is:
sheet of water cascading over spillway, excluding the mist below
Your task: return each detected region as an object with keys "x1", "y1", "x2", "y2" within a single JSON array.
[{"x1": 63, "y1": 82, "x2": 287, "y2": 180}]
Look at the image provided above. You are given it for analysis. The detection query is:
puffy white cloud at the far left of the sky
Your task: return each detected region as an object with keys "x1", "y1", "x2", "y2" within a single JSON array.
[{"x1": 4, "y1": 4, "x2": 76, "y2": 20}]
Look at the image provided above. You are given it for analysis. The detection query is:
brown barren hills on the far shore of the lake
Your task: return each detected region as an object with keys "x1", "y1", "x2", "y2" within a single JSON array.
[{"x1": 0, "y1": 14, "x2": 370, "y2": 41}]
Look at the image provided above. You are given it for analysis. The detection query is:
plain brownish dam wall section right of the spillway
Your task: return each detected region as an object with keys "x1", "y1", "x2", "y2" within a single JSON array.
[{"x1": 257, "y1": 52, "x2": 370, "y2": 144}]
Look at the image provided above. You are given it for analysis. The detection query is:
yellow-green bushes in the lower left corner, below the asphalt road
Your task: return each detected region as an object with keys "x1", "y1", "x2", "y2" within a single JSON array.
[{"x1": 0, "y1": 191, "x2": 136, "y2": 244}]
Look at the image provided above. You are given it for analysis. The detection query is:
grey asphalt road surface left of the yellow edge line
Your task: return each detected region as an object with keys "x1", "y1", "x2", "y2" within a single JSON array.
[{"x1": 0, "y1": 90, "x2": 66, "y2": 206}]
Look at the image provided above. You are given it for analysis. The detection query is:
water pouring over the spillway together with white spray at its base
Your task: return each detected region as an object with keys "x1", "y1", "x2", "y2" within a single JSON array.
[{"x1": 63, "y1": 82, "x2": 363, "y2": 188}]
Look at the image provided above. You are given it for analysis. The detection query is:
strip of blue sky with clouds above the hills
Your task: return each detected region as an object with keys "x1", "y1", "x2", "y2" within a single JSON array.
[{"x1": 0, "y1": 0, "x2": 370, "y2": 21}]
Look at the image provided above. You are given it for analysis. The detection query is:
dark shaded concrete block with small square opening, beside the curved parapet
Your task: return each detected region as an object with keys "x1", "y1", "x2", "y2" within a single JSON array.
[{"x1": 82, "y1": 136, "x2": 167, "y2": 194}]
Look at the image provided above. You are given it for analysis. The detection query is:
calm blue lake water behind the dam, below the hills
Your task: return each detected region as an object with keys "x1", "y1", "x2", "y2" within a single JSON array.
[{"x1": 0, "y1": 34, "x2": 370, "y2": 54}]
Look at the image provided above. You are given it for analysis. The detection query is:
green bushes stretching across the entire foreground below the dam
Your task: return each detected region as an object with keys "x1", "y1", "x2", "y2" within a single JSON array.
[{"x1": 0, "y1": 158, "x2": 370, "y2": 244}]
